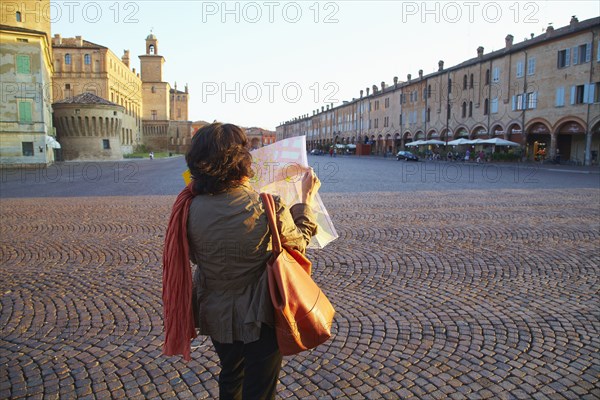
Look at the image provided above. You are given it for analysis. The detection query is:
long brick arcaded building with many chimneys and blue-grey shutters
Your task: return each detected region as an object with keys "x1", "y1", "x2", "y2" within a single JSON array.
[{"x1": 276, "y1": 17, "x2": 600, "y2": 165}]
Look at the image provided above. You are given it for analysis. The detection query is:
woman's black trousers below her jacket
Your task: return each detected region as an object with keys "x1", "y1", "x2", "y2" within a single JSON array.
[{"x1": 212, "y1": 324, "x2": 282, "y2": 400}]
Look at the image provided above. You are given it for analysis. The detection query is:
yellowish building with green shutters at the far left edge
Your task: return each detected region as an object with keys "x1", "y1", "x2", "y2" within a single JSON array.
[{"x1": 0, "y1": 1, "x2": 59, "y2": 166}]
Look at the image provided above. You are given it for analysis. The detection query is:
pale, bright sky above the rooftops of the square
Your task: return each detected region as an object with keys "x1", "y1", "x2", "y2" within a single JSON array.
[{"x1": 51, "y1": 0, "x2": 600, "y2": 130}]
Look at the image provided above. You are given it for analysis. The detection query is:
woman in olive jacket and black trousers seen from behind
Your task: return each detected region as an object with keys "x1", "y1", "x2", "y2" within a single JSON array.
[{"x1": 162, "y1": 123, "x2": 320, "y2": 399}]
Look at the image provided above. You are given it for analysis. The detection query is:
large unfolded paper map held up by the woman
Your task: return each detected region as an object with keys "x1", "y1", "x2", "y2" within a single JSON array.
[{"x1": 182, "y1": 136, "x2": 338, "y2": 248}]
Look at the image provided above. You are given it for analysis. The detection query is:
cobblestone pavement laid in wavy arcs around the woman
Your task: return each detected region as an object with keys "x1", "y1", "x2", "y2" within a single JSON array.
[{"x1": 0, "y1": 189, "x2": 600, "y2": 399}]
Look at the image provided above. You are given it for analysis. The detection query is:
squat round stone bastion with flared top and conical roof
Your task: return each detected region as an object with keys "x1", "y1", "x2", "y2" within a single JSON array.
[{"x1": 52, "y1": 92, "x2": 126, "y2": 160}]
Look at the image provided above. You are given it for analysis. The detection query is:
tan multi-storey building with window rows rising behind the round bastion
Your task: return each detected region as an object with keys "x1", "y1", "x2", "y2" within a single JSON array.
[{"x1": 52, "y1": 34, "x2": 143, "y2": 158}]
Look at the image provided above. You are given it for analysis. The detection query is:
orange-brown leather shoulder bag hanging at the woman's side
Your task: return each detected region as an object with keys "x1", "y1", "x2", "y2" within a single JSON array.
[{"x1": 260, "y1": 193, "x2": 335, "y2": 356}]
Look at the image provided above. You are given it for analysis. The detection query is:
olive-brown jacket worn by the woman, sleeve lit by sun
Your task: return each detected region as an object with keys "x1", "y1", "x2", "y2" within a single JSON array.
[{"x1": 188, "y1": 183, "x2": 317, "y2": 343}]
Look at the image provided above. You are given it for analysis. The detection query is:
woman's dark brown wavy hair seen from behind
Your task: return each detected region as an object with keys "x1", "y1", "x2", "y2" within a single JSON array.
[{"x1": 185, "y1": 122, "x2": 254, "y2": 194}]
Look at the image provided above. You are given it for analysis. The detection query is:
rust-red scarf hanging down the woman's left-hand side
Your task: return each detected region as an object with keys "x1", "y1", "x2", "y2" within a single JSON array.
[{"x1": 162, "y1": 181, "x2": 197, "y2": 361}]
